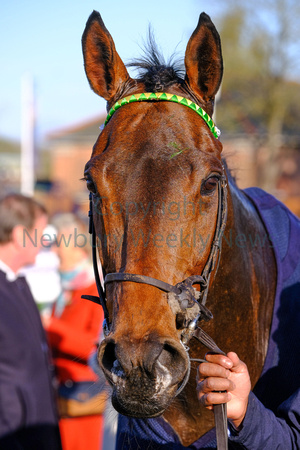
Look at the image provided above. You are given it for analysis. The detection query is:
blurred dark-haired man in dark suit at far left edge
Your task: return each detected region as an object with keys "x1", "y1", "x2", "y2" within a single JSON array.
[{"x1": 0, "y1": 194, "x2": 61, "y2": 450}]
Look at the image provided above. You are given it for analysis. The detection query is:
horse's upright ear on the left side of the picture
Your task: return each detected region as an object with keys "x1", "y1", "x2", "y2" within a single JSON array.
[{"x1": 82, "y1": 11, "x2": 130, "y2": 102}]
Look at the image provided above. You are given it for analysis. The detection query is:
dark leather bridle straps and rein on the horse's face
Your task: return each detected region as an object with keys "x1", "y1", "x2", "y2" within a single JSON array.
[{"x1": 82, "y1": 94, "x2": 228, "y2": 450}]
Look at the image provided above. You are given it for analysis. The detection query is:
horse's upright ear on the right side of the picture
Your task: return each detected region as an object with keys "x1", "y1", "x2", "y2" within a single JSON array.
[{"x1": 185, "y1": 13, "x2": 223, "y2": 107}]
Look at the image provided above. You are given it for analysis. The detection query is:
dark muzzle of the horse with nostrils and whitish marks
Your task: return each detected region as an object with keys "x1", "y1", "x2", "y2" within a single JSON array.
[{"x1": 98, "y1": 335, "x2": 189, "y2": 418}]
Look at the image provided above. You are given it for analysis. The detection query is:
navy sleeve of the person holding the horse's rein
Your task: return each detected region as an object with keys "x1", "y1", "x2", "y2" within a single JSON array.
[{"x1": 229, "y1": 389, "x2": 300, "y2": 450}]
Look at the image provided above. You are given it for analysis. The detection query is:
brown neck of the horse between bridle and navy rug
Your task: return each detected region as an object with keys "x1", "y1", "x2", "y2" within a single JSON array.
[{"x1": 208, "y1": 182, "x2": 276, "y2": 372}]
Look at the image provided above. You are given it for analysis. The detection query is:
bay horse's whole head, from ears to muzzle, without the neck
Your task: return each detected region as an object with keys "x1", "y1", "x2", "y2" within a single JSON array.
[{"x1": 82, "y1": 12, "x2": 224, "y2": 417}]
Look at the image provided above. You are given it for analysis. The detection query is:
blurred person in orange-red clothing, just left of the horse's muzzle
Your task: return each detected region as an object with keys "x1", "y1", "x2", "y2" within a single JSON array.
[{"x1": 44, "y1": 214, "x2": 107, "y2": 450}]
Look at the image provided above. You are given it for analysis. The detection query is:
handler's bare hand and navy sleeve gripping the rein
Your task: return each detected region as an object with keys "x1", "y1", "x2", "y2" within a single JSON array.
[{"x1": 197, "y1": 352, "x2": 300, "y2": 450}]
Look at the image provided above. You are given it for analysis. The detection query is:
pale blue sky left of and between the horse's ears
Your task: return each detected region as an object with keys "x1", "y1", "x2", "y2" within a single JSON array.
[{"x1": 0, "y1": 0, "x2": 227, "y2": 139}]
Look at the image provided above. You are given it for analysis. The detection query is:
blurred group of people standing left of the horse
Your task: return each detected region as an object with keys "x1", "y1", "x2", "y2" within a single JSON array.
[{"x1": 0, "y1": 194, "x2": 117, "y2": 450}]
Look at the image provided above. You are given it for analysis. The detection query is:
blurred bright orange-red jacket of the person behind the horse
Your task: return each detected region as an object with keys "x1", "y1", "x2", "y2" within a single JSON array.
[{"x1": 47, "y1": 283, "x2": 103, "y2": 383}]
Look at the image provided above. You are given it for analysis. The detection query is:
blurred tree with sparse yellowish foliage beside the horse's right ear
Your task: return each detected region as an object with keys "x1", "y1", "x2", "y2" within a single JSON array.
[{"x1": 214, "y1": 0, "x2": 300, "y2": 190}]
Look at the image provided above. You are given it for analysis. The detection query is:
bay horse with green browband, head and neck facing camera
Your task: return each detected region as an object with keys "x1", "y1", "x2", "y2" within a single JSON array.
[{"x1": 82, "y1": 11, "x2": 298, "y2": 448}]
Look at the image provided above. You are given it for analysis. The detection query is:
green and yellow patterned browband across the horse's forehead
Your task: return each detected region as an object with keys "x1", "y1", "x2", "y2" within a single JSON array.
[{"x1": 104, "y1": 92, "x2": 221, "y2": 139}]
